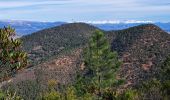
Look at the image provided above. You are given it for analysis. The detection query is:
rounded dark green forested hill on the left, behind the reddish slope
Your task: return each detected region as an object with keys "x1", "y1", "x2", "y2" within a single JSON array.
[{"x1": 22, "y1": 23, "x2": 97, "y2": 65}]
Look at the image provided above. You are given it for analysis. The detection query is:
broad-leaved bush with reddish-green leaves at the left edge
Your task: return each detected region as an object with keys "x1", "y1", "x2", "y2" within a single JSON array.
[{"x1": 0, "y1": 27, "x2": 27, "y2": 82}]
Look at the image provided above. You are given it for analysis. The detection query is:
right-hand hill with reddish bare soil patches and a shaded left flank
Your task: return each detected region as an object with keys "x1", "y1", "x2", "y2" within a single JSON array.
[{"x1": 109, "y1": 24, "x2": 170, "y2": 85}]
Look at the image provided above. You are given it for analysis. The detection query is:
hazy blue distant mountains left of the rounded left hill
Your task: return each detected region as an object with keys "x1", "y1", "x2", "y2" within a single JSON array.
[{"x1": 0, "y1": 20, "x2": 65, "y2": 36}]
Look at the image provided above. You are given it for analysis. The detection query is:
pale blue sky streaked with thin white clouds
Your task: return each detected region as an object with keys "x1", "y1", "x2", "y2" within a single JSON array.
[{"x1": 0, "y1": 0, "x2": 170, "y2": 22}]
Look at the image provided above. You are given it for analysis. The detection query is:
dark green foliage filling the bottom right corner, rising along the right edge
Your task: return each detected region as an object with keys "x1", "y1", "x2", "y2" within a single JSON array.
[{"x1": 132, "y1": 56, "x2": 170, "y2": 100}]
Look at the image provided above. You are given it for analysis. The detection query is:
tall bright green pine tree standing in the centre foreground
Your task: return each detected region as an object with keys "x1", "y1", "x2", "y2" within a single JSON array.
[{"x1": 77, "y1": 30, "x2": 121, "y2": 99}]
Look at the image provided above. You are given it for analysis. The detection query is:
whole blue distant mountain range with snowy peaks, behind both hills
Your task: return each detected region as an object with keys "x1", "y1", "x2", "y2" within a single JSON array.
[{"x1": 0, "y1": 20, "x2": 170, "y2": 36}]
